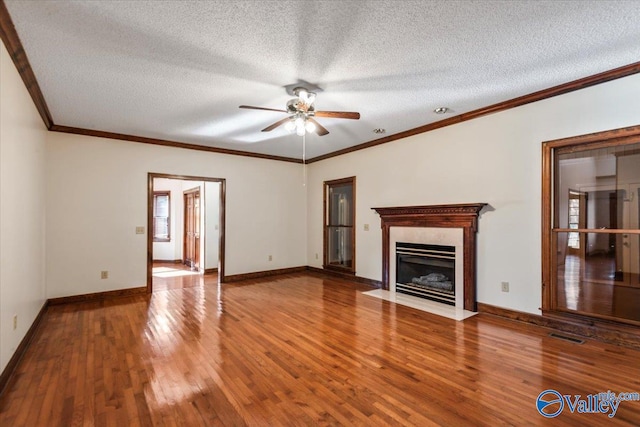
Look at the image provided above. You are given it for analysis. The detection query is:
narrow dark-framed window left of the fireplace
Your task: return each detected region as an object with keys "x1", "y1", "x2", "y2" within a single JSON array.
[{"x1": 323, "y1": 177, "x2": 356, "y2": 274}]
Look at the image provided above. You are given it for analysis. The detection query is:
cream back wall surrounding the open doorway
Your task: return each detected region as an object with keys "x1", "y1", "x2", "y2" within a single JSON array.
[{"x1": 46, "y1": 132, "x2": 306, "y2": 298}]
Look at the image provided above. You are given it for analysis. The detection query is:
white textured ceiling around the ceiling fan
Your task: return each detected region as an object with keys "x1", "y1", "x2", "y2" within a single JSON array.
[{"x1": 5, "y1": 0, "x2": 640, "y2": 158}]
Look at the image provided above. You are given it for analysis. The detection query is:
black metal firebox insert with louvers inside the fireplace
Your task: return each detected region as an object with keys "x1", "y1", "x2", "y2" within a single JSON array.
[{"x1": 396, "y1": 242, "x2": 456, "y2": 306}]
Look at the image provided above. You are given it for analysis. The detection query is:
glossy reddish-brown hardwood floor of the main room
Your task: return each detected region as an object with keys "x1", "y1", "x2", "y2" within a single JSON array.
[{"x1": 0, "y1": 273, "x2": 640, "y2": 426}]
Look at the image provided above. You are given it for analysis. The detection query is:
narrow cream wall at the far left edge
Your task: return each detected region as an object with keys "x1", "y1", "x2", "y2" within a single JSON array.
[{"x1": 0, "y1": 43, "x2": 47, "y2": 372}]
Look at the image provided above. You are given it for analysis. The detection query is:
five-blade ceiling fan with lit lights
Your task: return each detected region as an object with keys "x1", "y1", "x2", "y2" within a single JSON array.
[{"x1": 240, "y1": 86, "x2": 360, "y2": 136}]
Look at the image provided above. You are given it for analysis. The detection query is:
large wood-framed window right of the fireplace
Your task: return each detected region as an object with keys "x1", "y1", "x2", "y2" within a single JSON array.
[{"x1": 542, "y1": 128, "x2": 640, "y2": 324}]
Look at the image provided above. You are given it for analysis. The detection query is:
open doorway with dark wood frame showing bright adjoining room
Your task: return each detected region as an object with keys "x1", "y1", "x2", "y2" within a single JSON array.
[{"x1": 147, "y1": 173, "x2": 226, "y2": 292}]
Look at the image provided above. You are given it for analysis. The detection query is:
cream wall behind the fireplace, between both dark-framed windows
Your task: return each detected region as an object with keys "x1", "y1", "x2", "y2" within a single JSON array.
[{"x1": 307, "y1": 75, "x2": 640, "y2": 314}]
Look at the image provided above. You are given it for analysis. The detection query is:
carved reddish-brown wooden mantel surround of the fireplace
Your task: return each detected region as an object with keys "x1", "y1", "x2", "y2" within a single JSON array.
[{"x1": 372, "y1": 203, "x2": 487, "y2": 311}]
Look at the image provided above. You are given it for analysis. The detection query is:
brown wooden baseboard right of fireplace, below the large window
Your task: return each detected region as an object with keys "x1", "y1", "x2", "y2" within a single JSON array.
[{"x1": 478, "y1": 302, "x2": 640, "y2": 349}]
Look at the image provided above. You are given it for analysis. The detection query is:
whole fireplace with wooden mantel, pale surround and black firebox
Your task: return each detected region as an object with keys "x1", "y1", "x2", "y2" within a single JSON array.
[{"x1": 372, "y1": 203, "x2": 487, "y2": 312}]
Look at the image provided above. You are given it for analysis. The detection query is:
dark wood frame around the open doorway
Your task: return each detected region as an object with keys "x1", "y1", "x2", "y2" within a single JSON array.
[{"x1": 147, "y1": 172, "x2": 226, "y2": 293}]
